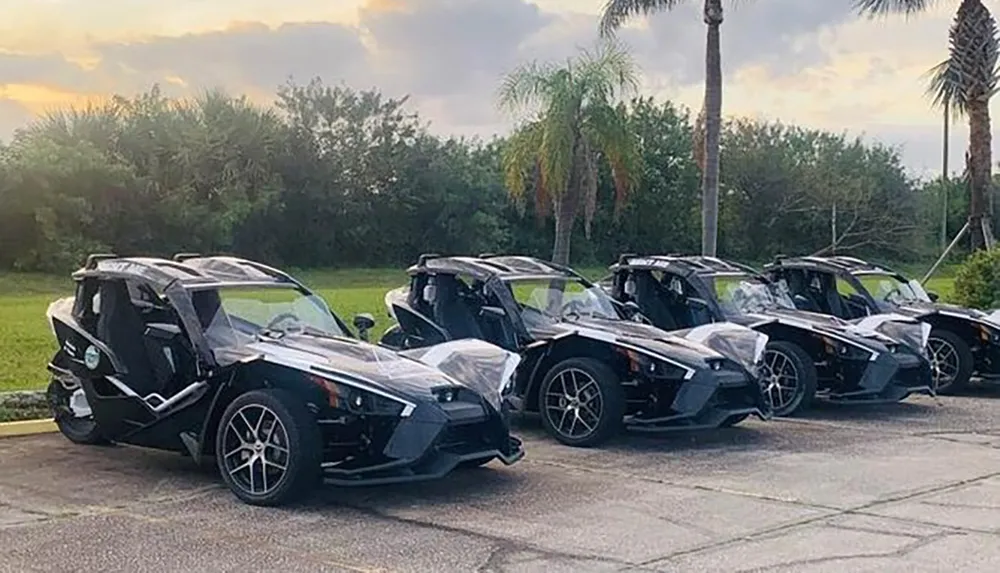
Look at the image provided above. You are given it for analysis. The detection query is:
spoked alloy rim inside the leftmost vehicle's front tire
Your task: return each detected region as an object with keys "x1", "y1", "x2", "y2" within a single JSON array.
[{"x1": 223, "y1": 404, "x2": 289, "y2": 496}]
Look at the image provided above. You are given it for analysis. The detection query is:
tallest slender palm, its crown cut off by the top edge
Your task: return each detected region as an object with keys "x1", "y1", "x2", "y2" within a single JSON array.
[{"x1": 600, "y1": 0, "x2": 724, "y2": 256}]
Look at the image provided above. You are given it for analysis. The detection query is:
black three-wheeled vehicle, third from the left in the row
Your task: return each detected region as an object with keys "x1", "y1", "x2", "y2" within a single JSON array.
[{"x1": 606, "y1": 255, "x2": 933, "y2": 416}]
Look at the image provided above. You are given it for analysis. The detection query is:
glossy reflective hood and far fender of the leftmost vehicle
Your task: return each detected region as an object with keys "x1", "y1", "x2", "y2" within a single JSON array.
[{"x1": 244, "y1": 328, "x2": 520, "y2": 410}]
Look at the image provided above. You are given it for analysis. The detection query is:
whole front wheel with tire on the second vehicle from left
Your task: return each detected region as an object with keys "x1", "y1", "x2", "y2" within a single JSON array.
[{"x1": 538, "y1": 358, "x2": 625, "y2": 447}]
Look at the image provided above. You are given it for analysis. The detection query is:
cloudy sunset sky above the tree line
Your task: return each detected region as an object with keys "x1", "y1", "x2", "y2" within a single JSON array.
[{"x1": 0, "y1": 0, "x2": 1000, "y2": 176}]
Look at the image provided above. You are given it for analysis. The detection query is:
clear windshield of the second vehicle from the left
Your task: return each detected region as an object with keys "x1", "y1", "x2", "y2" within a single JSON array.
[{"x1": 506, "y1": 277, "x2": 621, "y2": 328}]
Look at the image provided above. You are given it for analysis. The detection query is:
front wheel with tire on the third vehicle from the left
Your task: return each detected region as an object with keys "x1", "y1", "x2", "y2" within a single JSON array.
[{"x1": 761, "y1": 340, "x2": 817, "y2": 416}]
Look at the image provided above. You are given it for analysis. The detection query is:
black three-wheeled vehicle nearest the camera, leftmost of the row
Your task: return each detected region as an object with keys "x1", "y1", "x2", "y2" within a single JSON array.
[{"x1": 47, "y1": 256, "x2": 523, "y2": 505}]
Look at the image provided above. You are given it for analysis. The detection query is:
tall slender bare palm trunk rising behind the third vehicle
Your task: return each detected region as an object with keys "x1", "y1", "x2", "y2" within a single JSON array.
[{"x1": 701, "y1": 0, "x2": 722, "y2": 257}]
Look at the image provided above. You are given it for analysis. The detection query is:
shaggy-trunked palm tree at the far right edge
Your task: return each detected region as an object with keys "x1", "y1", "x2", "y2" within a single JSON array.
[{"x1": 855, "y1": 0, "x2": 1000, "y2": 250}]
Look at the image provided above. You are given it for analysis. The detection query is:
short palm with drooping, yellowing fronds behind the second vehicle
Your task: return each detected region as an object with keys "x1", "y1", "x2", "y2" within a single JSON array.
[{"x1": 498, "y1": 43, "x2": 638, "y2": 265}]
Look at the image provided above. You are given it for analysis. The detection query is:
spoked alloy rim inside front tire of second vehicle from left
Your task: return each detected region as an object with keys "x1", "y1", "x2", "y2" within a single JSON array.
[{"x1": 545, "y1": 368, "x2": 604, "y2": 439}]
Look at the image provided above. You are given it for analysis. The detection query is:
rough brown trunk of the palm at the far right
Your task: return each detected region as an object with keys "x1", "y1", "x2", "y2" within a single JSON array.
[{"x1": 969, "y1": 98, "x2": 993, "y2": 251}]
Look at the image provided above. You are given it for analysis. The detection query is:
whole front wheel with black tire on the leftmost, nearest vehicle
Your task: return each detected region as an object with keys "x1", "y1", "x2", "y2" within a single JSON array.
[{"x1": 215, "y1": 389, "x2": 322, "y2": 506}]
